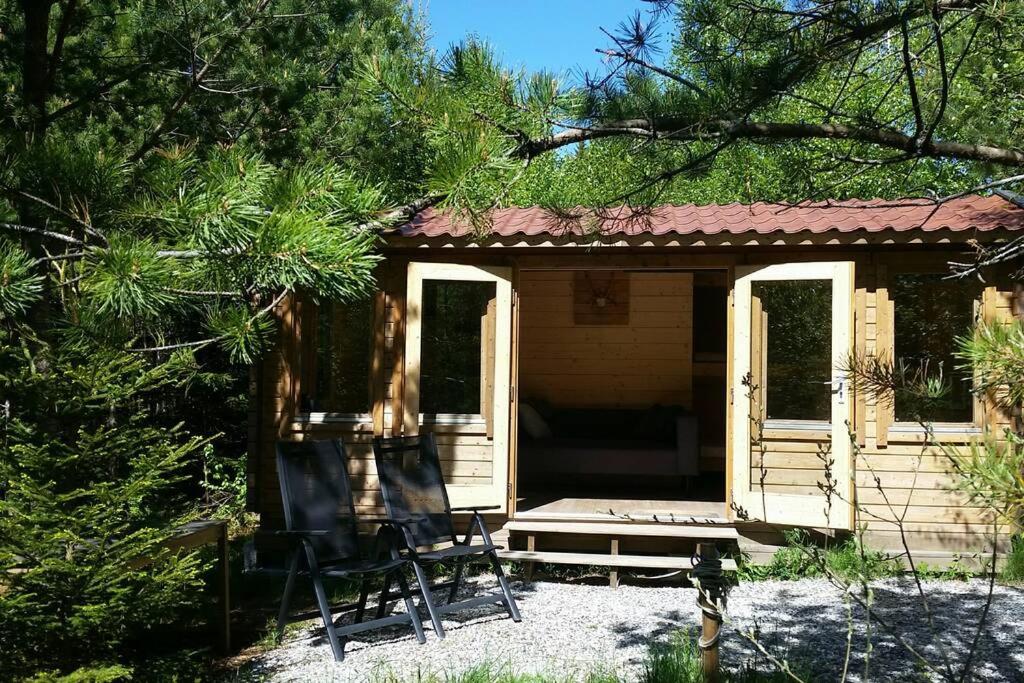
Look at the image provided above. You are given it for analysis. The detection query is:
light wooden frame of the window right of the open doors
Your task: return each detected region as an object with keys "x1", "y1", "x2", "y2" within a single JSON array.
[{"x1": 876, "y1": 264, "x2": 986, "y2": 442}]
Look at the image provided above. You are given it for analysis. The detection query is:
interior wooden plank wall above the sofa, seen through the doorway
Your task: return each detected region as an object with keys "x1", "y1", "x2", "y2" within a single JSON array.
[{"x1": 519, "y1": 271, "x2": 693, "y2": 408}]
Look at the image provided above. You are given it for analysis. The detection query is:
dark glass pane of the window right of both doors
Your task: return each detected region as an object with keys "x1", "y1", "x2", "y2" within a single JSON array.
[{"x1": 891, "y1": 273, "x2": 981, "y2": 422}]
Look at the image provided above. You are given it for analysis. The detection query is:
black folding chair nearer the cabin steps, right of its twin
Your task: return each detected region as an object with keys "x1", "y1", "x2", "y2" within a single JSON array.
[{"x1": 374, "y1": 434, "x2": 522, "y2": 638}]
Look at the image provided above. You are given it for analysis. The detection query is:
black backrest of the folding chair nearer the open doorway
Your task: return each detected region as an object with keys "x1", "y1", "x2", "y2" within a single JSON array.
[{"x1": 374, "y1": 434, "x2": 456, "y2": 546}]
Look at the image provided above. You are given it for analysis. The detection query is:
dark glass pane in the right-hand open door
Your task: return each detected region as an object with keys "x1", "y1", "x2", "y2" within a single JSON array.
[{"x1": 752, "y1": 280, "x2": 833, "y2": 421}]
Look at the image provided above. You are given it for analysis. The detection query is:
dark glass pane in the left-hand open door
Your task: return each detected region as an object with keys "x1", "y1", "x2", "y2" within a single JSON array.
[{"x1": 420, "y1": 280, "x2": 497, "y2": 415}]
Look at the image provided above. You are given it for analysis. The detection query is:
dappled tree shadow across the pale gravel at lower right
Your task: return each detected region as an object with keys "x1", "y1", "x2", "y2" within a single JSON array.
[{"x1": 613, "y1": 580, "x2": 1024, "y2": 683}]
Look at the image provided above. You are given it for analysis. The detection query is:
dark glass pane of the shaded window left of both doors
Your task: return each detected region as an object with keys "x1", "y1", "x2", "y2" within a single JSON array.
[{"x1": 310, "y1": 297, "x2": 374, "y2": 413}]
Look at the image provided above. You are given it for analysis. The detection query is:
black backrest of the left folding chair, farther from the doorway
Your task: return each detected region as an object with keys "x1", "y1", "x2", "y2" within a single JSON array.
[{"x1": 278, "y1": 440, "x2": 359, "y2": 563}]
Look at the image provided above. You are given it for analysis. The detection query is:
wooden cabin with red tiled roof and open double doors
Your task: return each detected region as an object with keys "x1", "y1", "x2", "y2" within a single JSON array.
[{"x1": 249, "y1": 196, "x2": 1024, "y2": 567}]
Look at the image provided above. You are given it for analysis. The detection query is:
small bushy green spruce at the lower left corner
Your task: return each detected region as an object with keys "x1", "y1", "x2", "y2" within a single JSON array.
[{"x1": 0, "y1": 332, "x2": 203, "y2": 680}]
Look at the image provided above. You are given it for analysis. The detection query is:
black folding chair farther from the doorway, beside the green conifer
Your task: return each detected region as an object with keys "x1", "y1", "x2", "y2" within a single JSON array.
[{"x1": 278, "y1": 440, "x2": 426, "y2": 661}]
